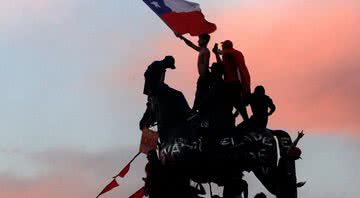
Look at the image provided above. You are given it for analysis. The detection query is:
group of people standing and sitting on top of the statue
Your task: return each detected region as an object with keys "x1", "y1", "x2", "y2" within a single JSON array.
[{"x1": 140, "y1": 34, "x2": 276, "y2": 129}]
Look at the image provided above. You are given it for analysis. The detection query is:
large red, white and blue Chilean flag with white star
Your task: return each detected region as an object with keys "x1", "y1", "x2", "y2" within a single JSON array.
[{"x1": 143, "y1": 0, "x2": 216, "y2": 36}]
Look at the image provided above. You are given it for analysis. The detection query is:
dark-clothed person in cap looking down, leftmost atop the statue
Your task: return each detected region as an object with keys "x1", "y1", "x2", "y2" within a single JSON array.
[{"x1": 139, "y1": 56, "x2": 176, "y2": 130}]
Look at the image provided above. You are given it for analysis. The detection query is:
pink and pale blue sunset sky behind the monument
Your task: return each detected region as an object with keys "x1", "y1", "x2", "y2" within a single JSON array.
[{"x1": 0, "y1": 0, "x2": 360, "y2": 198}]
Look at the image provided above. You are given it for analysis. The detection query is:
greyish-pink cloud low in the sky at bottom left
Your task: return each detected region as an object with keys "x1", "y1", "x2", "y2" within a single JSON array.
[{"x1": 0, "y1": 148, "x2": 145, "y2": 198}]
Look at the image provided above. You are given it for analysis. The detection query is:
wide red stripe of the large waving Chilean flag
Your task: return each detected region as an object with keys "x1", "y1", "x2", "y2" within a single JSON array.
[{"x1": 160, "y1": 11, "x2": 216, "y2": 36}]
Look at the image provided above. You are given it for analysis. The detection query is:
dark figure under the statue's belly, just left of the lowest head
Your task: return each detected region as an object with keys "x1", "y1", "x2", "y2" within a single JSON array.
[{"x1": 223, "y1": 178, "x2": 248, "y2": 198}]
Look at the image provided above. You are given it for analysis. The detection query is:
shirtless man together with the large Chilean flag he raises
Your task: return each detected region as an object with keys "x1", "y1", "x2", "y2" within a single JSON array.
[{"x1": 143, "y1": 0, "x2": 216, "y2": 113}]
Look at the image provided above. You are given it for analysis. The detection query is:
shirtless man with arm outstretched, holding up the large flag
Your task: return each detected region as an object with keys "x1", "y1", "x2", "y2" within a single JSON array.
[{"x1": 175, "y1": 33, "x2": 210, "y2": 112}]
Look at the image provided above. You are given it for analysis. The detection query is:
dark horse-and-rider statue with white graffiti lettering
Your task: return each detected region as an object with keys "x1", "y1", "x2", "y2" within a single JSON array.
[{"x1": 139, "y1": 77, "x2": 297, "y2": 198}]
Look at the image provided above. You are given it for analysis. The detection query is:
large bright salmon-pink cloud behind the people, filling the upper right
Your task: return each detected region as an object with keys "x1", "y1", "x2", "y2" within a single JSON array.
[{"x1": 154, "y1": 1, "x2": 360, "y2": 131}]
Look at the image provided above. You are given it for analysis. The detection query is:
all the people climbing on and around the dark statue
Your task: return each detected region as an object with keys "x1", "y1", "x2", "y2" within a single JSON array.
[{"x1": 139, "y1": 33, "x2": 304, "y2": 198}]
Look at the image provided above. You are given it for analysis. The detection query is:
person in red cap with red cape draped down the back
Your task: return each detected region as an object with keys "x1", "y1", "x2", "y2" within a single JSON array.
[{"x1": 213, "y1": 40, "x2": 250, "y2": 121}]
